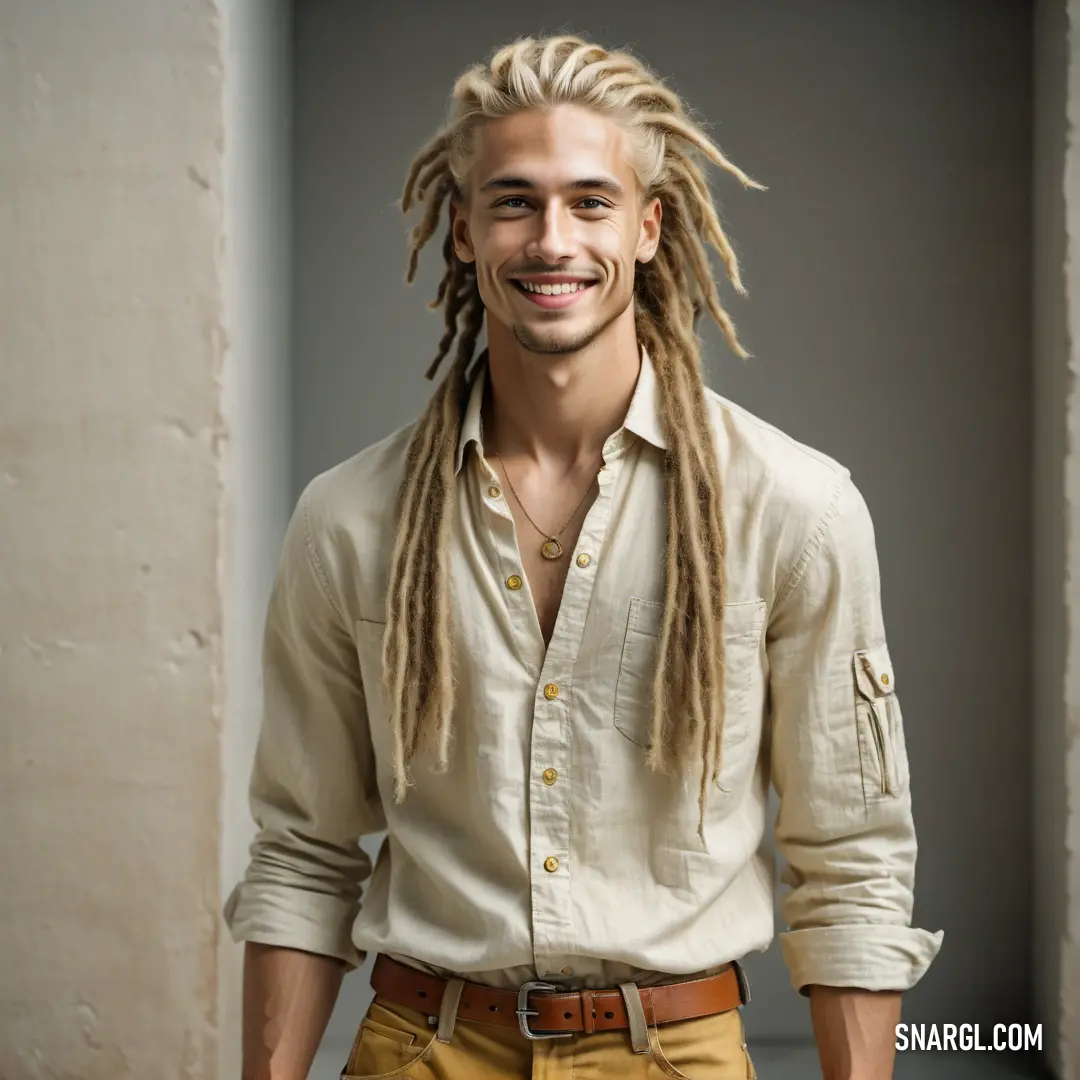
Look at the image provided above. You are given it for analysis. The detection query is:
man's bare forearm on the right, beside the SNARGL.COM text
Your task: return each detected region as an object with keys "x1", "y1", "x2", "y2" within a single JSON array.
[{"x1": 810, "y1": 986, "x2": 901, "y2": 1080}]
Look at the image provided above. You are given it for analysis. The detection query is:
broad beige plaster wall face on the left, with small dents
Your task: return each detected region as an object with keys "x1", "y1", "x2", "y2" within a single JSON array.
[{"x1": 0, "y1": 0, "x2": 224, "y2": 1080}]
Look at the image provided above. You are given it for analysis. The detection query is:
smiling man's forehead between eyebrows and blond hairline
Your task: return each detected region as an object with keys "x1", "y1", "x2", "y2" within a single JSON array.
[{"x1": 470, "y1": 105, "x2": 634, "y2": 187}]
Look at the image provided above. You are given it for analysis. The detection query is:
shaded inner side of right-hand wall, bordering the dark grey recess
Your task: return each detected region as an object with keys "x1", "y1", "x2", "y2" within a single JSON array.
[{"x1": 1031, "y1": 0, "x2": 1080, "y2": 1080}]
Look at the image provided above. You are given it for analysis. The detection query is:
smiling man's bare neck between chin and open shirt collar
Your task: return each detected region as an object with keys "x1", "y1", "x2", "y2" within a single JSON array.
[{"x1": 484, "y1": 311, "x2": 642, "y2": 469}]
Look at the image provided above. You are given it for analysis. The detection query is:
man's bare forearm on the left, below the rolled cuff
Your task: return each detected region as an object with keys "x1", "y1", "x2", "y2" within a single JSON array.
[{"x1": 242, "y1": 942, "x2": 346, "y2": 1080}]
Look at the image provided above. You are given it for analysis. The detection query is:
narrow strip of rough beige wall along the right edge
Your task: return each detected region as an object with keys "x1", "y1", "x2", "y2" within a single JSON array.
[{"x1": 1034, "y1": 0, "x2": 1080, "y2": 1080}]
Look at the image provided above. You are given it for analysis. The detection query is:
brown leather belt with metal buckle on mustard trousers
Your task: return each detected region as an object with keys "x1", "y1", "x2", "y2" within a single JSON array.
[{"x1": 372, "y1": 954, "x2": 750, "y2": 1036}]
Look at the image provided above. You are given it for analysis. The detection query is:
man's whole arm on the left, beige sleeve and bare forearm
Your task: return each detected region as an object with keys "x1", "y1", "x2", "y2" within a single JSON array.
[{"x1": 225, "y1": 481, "x2": 386, "y2": 1080}]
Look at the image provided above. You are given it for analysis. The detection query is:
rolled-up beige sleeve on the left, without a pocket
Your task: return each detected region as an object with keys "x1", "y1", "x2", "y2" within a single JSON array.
[{"x1": 225, "y1": 482, "x2": 386, "y2": 968}]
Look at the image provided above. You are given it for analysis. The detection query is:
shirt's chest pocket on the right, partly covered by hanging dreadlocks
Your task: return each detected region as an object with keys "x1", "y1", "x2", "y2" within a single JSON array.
[{"x1": 615, "y1": 596, "x2": 765, "y2": 748}]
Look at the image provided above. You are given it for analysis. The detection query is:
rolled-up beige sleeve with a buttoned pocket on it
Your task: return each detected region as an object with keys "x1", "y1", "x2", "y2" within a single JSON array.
[{"x1": 768, "y1": 474, "x2": 943, "y2": 996}]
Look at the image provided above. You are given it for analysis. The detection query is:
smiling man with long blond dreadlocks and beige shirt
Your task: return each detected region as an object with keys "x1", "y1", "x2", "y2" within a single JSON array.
[{"x1": 227, "y1": 37, "x2": 941, "y2": 1080}]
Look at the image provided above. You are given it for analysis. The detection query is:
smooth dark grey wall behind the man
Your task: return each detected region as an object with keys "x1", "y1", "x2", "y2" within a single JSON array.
[{"x1": 294, "y1": 0, "x2": 1032, "y2": 1040}]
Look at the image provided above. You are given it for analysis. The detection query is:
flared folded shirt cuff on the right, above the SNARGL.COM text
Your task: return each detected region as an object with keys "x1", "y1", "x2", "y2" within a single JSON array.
[{"x1": 780, "y1": 923, "x2": 945, "y2": 997}]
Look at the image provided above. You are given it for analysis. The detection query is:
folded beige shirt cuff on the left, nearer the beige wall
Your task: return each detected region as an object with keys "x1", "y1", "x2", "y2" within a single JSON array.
[{"x1": 224, "y1": 882, "x2": 366, "y2": 971}]
